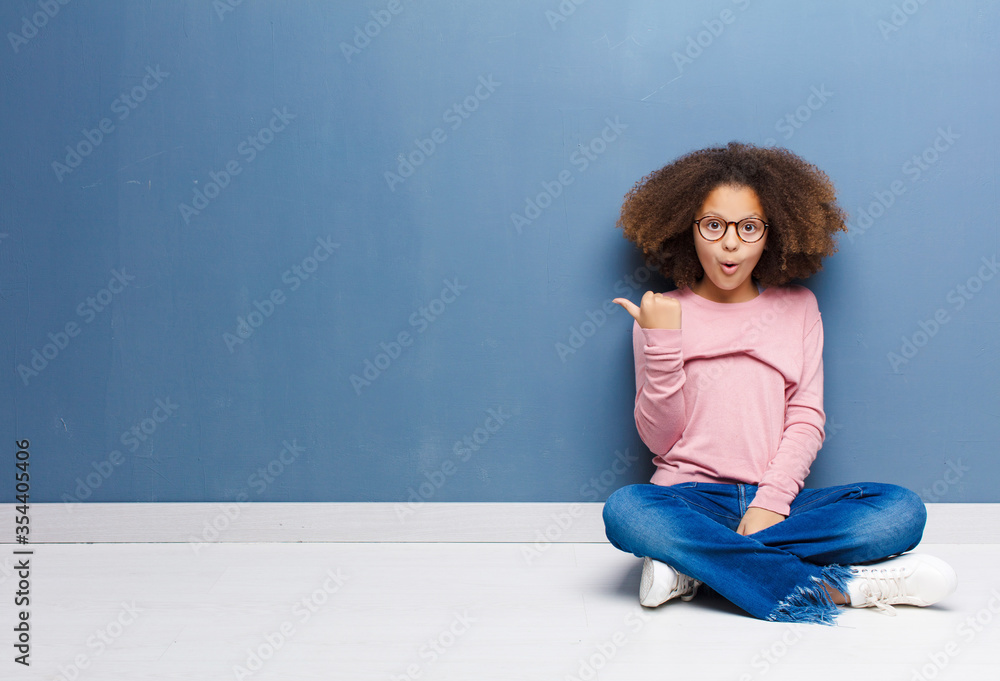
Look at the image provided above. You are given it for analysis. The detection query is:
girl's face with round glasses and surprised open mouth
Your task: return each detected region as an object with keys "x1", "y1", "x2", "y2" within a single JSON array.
[{"x1": 691, "y1": 185, "x2": 767, "y2": 303}]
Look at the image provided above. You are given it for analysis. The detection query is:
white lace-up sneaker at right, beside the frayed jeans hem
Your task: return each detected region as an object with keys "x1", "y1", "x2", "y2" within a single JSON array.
[{"x1": 847, "y1": 553, "x2": 958, "y2": 615}]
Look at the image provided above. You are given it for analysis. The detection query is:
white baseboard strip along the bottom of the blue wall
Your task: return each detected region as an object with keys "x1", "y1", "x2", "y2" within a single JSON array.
[{"x1": 0, "y1": 502, "x2": 1000, "y2": 544}]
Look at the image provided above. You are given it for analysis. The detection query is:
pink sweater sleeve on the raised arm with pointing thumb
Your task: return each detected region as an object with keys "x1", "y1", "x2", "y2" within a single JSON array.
[{"x1": 632, "y1": 322, "x2": 685, "y2": 454}]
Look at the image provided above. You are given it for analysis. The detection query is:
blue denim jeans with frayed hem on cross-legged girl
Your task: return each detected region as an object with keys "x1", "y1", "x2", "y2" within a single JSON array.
[{"x1": 604, "y1": 482, "x2": 927, "y2": 624}]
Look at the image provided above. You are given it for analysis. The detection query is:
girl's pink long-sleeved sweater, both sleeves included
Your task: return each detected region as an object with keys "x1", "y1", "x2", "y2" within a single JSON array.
[{"x1": 632, "y1": 286, "x2": 826, "y2": 515}]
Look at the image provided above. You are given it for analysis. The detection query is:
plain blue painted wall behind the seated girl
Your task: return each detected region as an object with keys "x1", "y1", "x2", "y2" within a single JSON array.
[{"x1": 0, "y1": 0, "x2": 1000, "y2": 504}]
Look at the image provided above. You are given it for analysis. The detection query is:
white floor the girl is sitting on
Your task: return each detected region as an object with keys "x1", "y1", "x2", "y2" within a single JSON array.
[{"x1": 0, "y1": 543, "x2": 1000, "y2": 681}]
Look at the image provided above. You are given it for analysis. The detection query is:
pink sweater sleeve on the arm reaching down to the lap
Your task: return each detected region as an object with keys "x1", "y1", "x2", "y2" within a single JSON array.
[{"x1": 750, "y1": 310, "x2": 826, "y2": 516}]
